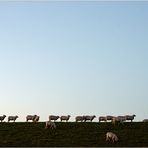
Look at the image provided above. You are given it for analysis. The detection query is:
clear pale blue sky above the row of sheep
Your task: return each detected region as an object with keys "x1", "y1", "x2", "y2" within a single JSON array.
[{"x1": 0, "y1": 1, "x2": 148, "y2": 122}]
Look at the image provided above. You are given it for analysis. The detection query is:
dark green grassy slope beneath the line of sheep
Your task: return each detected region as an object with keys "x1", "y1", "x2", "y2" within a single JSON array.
[{"x1": 0, "y1": 122, "x2": 148, "y2": 147}]
